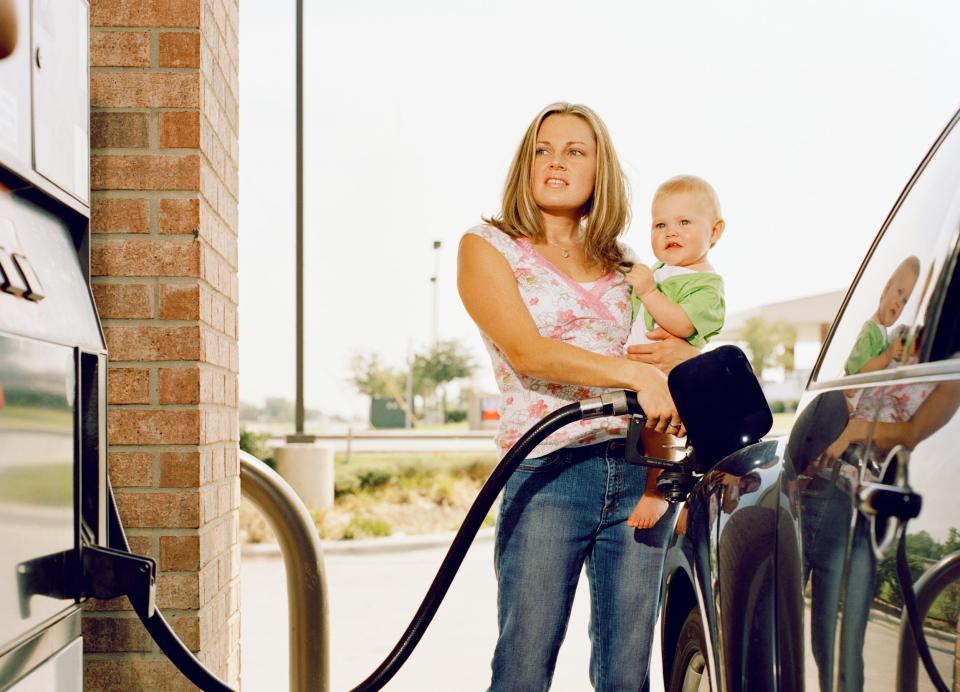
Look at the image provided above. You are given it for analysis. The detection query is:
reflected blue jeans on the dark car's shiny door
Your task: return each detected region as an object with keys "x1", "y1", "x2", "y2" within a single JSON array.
[{"x1": 801, "y1": 476, "x2": 877, "y2": 692}]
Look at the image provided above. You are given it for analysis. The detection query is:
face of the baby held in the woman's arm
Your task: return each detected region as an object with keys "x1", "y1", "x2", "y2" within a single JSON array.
[{"x1": 650, "y1": 192, "x2": 723, "y2": 267}]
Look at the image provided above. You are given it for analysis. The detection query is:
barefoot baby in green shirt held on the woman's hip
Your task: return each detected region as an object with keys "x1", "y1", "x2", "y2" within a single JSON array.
[{"x1": 626, "y1": 175, "x2": 725, "y2": 529}]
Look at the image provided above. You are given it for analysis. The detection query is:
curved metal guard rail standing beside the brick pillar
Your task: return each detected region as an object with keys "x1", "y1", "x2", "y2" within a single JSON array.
[{"x1": 240, "y1": 451, "x2": 330, "y2": 692}]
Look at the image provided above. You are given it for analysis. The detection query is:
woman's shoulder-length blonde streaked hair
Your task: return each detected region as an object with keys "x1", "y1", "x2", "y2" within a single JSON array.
[{"x1": 484, "y1": 102, "x2": 630, "y2": 271}]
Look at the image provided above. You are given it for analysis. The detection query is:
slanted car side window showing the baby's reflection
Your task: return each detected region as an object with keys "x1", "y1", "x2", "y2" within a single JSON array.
[{"x1": 815, "y1": 115, "x2": 960, "y2": 381}]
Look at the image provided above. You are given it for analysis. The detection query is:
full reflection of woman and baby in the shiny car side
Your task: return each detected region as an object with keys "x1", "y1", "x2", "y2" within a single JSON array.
[{"x1": 802, "y1": 256, "x2": 960, "y2": 690}]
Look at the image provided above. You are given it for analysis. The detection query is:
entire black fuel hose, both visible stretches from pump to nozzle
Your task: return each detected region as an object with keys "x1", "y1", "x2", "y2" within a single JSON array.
[{"x1": 99, "y1": 390, "x2": 643, "y2": 692}]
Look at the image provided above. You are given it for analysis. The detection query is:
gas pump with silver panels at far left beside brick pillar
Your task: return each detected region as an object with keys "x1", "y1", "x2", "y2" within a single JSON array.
[{"x1": 0, "y1": 0, "x2": 107, "y2": 690}]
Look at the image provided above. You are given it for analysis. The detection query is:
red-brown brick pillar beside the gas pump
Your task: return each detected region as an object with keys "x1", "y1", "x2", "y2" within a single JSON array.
[{"x1": 83, "y1": 0, "x2": 240, "y2": 692}]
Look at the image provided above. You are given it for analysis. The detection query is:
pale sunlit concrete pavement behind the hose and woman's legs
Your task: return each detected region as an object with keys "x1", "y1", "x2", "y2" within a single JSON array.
[{"x1": 241, "y1": 529, "x2": 659, "y2": 692}]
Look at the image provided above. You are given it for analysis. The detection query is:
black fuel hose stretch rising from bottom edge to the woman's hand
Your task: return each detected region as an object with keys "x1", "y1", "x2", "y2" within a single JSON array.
[{"x1": 351, "y1": 390, "x2": 642, "y2": 692}]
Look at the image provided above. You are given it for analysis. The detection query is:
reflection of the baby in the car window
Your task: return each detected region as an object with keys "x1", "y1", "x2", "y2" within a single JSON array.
[{"x1": 843, "y1": 255, "x2": 920, "y2": 375}]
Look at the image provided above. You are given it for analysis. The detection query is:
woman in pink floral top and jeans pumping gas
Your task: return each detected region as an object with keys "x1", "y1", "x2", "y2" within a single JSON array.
[{"x1": 458, "y1": 103, "x2": 696, "y2": 692}]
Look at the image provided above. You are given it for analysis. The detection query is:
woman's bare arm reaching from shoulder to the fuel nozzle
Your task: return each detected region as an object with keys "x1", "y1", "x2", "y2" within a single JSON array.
[{"x1": 457, "y1": 234, "x2": 679, "y2": 431}]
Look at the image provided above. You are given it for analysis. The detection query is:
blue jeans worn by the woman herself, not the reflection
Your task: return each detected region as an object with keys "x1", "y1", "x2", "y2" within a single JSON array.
[{"x1": 490, "y1": 442, "x2": 675, "y2": 692}]
